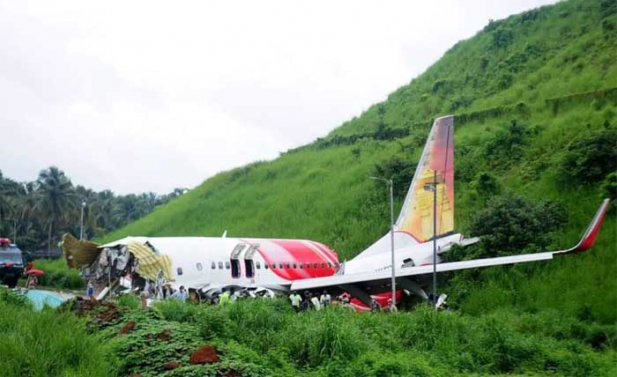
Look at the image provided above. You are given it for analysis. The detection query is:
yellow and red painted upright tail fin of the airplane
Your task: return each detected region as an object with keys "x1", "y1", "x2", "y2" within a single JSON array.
[{"x1": 395, "y1": 115, "x2": 454, "y2": 242}]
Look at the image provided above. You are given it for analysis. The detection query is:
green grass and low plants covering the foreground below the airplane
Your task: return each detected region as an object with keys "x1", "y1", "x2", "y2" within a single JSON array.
[{"x1": 0, "y1": 291, "x2": 617, "y2": 377}]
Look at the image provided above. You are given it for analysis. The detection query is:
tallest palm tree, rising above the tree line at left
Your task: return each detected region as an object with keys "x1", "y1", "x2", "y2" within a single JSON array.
[{"x1": 37, "y1": 166, "x2": 76, "y2": 250}]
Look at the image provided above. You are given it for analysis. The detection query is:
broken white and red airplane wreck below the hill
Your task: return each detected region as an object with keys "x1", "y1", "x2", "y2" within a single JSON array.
[{"x1": 62, "y1": 116, "x2": 609, "y2": 310}]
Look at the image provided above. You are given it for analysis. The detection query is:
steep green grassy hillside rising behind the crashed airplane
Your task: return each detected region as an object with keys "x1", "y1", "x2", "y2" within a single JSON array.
[{"x1": 103, "y1": 0, "x2": 617, "y2": 324}]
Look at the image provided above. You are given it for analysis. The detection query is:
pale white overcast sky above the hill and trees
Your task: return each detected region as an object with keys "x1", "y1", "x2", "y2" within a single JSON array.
[{"x1": 0, "y1": 0, "x2": 554, "y2": 193}]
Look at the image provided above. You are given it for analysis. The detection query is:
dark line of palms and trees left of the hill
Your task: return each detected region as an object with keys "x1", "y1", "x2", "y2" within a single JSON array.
[{"x1": 0, "y1": 166, "x2": 186, "y2": 250}]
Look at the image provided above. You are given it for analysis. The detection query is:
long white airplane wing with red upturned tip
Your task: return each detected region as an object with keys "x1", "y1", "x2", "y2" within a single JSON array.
[{"x1": 291, "y1": 199, "x2": 609, "y2": 301}]
